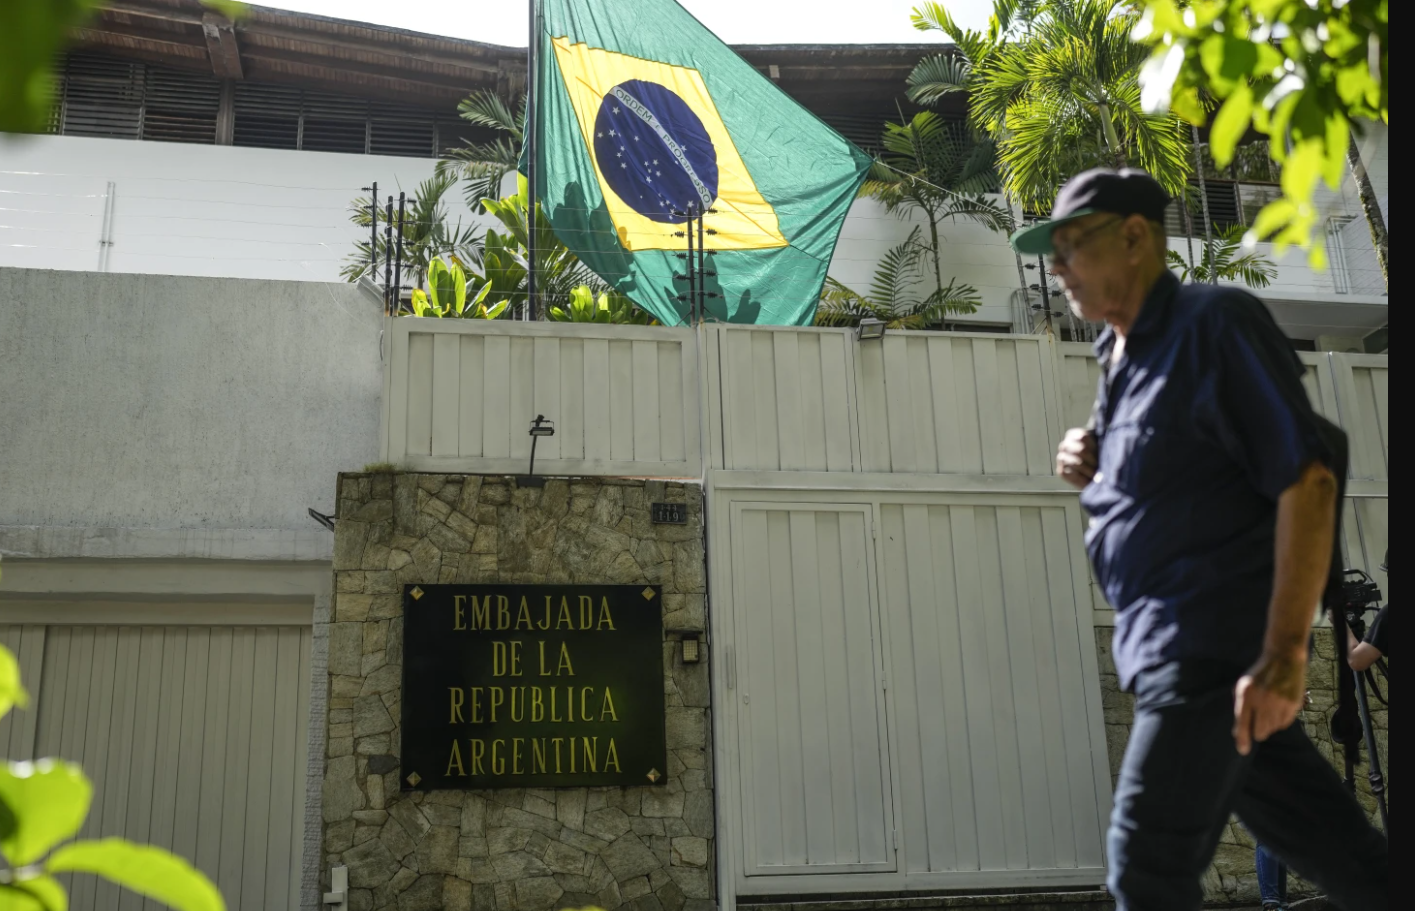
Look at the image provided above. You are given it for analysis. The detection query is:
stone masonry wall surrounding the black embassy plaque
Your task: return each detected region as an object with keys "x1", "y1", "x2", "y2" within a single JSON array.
[{"x1": 321, "y1": 474, "x2": 716, "y2": 911}]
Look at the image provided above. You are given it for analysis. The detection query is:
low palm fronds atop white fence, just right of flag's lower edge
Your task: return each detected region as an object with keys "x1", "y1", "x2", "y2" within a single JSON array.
[{"x1": 815, "y1": 226, "x2": 982, "y2": 330}]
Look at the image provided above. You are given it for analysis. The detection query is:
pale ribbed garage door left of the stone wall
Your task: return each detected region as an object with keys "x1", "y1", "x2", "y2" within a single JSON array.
[{"x1": 0, "y1": 625, "x2": 310, "y2": 911}]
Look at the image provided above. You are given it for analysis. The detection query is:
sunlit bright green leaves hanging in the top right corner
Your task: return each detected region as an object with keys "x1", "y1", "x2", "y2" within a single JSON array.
[{"x1": 1133, "y1": 0, "x2": 1390, "y2": 267}]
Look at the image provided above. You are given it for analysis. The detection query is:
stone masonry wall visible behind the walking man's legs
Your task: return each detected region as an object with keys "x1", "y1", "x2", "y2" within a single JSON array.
[{"x1": 1095, "y1": 627, "x2": 1391, "y2": 904}]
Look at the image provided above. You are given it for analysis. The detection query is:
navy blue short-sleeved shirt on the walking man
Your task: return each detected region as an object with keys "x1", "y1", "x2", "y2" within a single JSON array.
[{"x1": 1081, "y1": 273, "x2": 1332, "y2": 689}]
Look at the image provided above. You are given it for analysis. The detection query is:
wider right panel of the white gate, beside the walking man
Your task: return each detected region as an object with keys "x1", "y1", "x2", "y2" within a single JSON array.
[{"x1": 880, "y1": 498, "x2": 1108, "y2": 874}]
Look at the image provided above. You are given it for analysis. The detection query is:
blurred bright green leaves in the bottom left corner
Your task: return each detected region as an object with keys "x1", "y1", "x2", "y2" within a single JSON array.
[{"x1": 0, "y1": 645, "x2": 226, "y2": 911}]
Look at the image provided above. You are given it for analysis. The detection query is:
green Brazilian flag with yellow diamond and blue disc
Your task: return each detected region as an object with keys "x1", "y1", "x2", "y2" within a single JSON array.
[{"x1": 535, "y1": 0, "x2": 870, "y2": 325}]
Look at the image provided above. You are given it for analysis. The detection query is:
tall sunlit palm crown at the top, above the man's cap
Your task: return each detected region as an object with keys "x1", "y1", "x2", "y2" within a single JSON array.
[{"x1": 908, "y1": 0, "x2": 1191, "y2": 209}]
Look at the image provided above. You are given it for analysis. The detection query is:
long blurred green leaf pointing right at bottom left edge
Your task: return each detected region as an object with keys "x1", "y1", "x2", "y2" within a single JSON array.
[{"x1": 45, "y1": 839, "x2": 226, "y2": 911}]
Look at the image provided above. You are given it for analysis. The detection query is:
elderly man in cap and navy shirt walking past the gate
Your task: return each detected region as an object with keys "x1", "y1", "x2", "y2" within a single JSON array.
[{"x1": 1012, "y1": 170, "x2": 1388, "y2": 911}]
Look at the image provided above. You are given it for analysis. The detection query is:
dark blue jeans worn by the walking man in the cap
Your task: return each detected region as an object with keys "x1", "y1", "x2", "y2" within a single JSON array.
[{"x1": 1108, "y1": 662, "x2": 1390, "y2": 911}]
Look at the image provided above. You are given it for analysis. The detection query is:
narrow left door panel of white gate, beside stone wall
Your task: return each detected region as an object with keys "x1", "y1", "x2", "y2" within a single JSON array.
[{"x1": 732, "y1": 504, "x2": 896, "y2": 877}]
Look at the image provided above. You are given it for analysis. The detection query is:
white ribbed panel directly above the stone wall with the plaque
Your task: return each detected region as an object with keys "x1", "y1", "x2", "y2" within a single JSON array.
[{"x1": 383, "y1": 317, "x2": 702, "y2": 477}]
